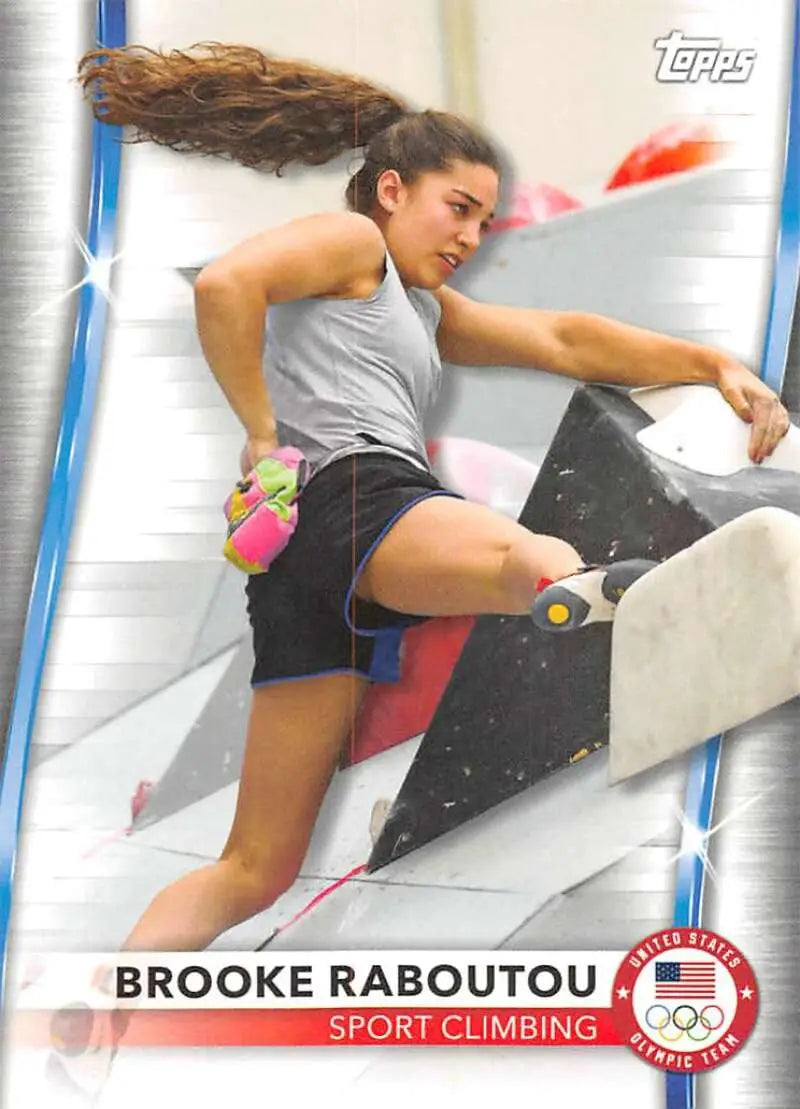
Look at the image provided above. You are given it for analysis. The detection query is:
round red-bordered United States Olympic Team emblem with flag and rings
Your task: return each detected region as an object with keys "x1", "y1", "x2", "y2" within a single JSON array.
[{"x1": 611, "y1": 928, "x2": 758, "y2": 1072}]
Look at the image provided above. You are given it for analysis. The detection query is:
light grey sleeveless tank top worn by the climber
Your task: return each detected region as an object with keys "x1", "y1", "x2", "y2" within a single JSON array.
[{"x1": 265, "y1": 252, "x2": 442, "y2": 466}]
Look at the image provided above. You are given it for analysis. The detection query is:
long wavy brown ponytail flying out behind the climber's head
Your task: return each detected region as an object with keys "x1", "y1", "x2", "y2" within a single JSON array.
[{"x1": 78, "y1": 42, "x2": 408, "y2": 174}]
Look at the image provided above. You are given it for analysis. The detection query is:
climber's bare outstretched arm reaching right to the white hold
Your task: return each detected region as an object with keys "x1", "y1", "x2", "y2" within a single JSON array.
[{"x1": 437, "y1": 287, "x2": 789, "y2": 461}]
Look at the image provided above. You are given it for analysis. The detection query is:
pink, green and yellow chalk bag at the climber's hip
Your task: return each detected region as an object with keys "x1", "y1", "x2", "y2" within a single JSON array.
[{"x1": 223, "y1": 447, "x2": 311, "y2": 573}]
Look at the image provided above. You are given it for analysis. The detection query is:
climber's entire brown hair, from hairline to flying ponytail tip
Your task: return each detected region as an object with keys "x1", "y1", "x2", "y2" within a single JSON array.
[{"x1": 78, "y1": 42, "x2": 500, "y2": 213}]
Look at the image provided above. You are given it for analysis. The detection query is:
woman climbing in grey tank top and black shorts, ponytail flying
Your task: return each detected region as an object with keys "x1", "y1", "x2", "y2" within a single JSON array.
[{"x1": 80, "y1": 44, "x2": 789, "y2": 950}]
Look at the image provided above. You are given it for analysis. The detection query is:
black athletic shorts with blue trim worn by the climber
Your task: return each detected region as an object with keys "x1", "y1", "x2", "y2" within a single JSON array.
[{"x1": 246, "y1": 452, "x2": 458, "y2": 686}]
